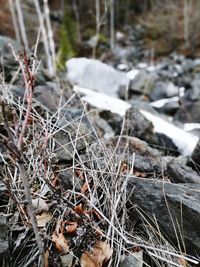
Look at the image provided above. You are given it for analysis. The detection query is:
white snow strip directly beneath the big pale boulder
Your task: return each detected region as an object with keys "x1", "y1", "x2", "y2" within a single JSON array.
[{"x1": 74, "y1": 85, "x2": 131, "y2": 116}]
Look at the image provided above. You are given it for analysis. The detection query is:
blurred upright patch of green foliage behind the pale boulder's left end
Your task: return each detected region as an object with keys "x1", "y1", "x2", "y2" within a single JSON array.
[{"x1": 57, "y1": 5, "x2": 77, "y2": 69}]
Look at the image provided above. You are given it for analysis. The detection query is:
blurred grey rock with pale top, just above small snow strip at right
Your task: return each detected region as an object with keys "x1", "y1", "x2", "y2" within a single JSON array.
[{"x1": 150, "y1": 81, "x2": 178, "y2": 101}]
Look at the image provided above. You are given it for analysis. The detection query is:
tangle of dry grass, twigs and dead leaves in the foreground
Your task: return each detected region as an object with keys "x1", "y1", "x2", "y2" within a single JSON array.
[{"x1": 1, "y1": 64, "x2": 197, "y2": 267}]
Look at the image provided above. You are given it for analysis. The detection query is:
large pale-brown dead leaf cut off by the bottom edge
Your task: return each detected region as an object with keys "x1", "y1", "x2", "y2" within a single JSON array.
[{"x1": 81, "y1": 241, "x2": 113, "y2": 267}]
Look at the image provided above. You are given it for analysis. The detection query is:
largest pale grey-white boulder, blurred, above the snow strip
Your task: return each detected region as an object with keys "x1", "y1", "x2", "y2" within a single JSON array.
[{"x1": 66, "y1": 58, "x2": 129, "y2": 97}]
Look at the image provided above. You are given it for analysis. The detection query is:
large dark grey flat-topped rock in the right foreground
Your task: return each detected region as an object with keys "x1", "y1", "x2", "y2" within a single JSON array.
[{"x1": 127, "y1": 178, "x2": 200, "y2": 256}]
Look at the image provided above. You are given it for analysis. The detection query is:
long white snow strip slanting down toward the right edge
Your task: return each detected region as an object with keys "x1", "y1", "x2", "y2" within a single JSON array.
[{"x1": 140, "y1": 110, "x2": 199, "y2": 156}]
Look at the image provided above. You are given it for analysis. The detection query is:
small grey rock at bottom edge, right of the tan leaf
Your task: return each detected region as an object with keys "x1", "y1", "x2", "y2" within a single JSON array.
[{"x1": 119, "y1": 250, "x2": 143, "y2": 267}]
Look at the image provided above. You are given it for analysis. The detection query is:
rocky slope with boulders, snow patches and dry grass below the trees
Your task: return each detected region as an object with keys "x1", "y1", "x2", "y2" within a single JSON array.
[{"x1": 0, "y1": 24, "x2": 200, "y2": 267}]
